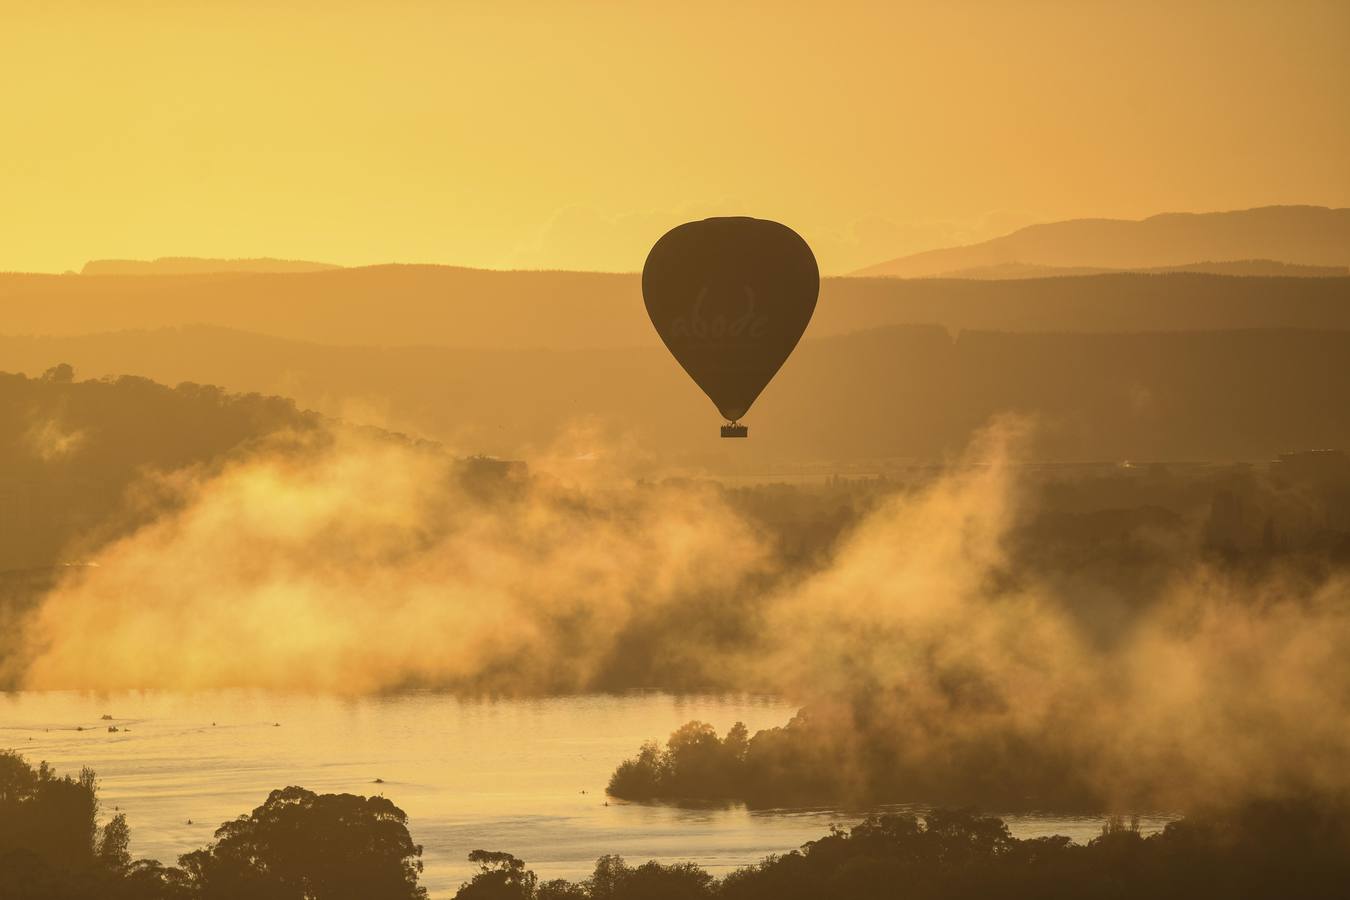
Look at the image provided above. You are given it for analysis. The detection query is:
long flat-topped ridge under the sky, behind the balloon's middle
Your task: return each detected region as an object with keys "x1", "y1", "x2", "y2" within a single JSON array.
[{"x1": 0, "y1": 266, "x2": 1350, "y2": 348}]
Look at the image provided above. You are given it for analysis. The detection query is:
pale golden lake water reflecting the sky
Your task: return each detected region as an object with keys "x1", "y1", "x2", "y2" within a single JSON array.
[{"x1": 0, "y1": 691, "x2": 1165, "y2": 896}]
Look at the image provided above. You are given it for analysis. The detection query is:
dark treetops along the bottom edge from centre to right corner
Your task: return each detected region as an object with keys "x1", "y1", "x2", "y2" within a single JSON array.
[{"x1": 456, "y1": 800, "x2": 1350, "y2": 900}]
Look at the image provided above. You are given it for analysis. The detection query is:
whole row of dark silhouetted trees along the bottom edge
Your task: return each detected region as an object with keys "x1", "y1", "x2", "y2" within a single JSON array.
[{"x1": 0, "y1": 752, "x2": 1350, "y2": 900}]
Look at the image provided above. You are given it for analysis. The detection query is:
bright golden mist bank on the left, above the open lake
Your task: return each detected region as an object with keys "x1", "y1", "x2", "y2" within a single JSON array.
[{"x1": 15, "y1": 436, "x2": 764, "y2": 692}]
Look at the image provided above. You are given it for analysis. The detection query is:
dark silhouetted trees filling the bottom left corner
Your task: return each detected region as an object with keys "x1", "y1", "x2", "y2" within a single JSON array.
[{"x1": 0, "y1": 752, "x2": 427, "y2": 900}]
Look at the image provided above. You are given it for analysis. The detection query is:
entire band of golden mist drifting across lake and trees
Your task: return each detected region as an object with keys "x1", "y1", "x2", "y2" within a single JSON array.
[{"x1": 13, "y1": 420, "x2": 1350, "y2": 803}]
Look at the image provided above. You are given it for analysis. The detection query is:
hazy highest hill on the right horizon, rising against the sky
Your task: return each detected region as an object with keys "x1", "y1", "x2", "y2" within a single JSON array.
[{"x1": 855, "y1": 206, "x2": 1350, "y2": 278}]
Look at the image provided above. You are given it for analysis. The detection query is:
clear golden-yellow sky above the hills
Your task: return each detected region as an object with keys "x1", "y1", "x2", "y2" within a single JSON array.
[{"x1": 0, "y1": 0, "x2": 1350, "y2": 273}]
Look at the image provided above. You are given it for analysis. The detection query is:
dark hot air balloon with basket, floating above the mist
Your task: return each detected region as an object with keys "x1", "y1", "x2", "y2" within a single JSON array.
[{"x1": 643, "y1": 217, "x2": 821, "y2": 437}]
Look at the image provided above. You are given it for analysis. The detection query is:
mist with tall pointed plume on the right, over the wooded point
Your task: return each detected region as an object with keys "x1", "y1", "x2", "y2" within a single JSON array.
[{"x1": 768, "y1": 421, "x2": 1350, "y2": 804}]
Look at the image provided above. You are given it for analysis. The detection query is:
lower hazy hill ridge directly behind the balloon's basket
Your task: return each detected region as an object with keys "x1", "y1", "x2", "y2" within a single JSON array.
[{"x1": 0, "y1": 325, "x2": 1350, "y2": 472}]
